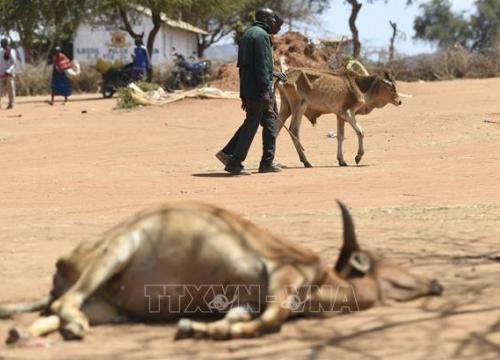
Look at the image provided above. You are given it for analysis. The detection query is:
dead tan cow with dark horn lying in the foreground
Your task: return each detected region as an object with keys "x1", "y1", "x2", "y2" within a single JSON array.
[{"x1": 0, "y1": 203, "x2": 442, "y2": 345}]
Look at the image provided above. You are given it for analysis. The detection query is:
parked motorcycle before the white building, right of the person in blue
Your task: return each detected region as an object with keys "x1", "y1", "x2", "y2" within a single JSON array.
[{"x1": 165, "y1": 49, "x2": 211, "y2": 92}]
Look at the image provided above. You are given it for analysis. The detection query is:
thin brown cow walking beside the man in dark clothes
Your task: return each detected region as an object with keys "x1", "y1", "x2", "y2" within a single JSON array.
[{"x1": 278, "y1": 68, "x2": 401, "y2": 167}]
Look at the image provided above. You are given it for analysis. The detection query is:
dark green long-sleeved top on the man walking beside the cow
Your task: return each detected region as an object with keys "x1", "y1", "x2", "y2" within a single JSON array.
[{"x1": 238, "y1": 22, "x2": 273, "y2": 99}]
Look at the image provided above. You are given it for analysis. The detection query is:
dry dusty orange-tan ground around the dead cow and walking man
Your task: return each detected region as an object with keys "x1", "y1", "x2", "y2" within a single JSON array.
[{"x1": 0, "y1": 79, "x2": 500, "y2": 359}]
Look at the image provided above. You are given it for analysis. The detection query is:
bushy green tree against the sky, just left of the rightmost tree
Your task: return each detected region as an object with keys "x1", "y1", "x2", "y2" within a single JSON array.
[{"x1": 413, "y1": 0, "x2": 471, "y2": 48}]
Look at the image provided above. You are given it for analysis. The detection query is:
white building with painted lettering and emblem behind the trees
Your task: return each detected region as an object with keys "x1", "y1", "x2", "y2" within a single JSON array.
[{"x1": 73, "y1": 7, "x2": 207, "y2": 65}]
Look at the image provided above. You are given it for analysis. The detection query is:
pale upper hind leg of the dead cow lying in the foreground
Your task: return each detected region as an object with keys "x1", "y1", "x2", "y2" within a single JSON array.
[{"x1": 51, "y1": 230, "x2": 142, "y2": 340}]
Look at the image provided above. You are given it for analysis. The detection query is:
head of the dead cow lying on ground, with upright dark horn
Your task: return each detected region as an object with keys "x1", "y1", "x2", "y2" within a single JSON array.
[{"x1": 335, "y1": 202, "x2": 443, "y2": 305}]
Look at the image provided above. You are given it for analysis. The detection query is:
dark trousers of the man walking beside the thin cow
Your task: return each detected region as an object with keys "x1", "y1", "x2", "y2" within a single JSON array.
[{"x1": 222, "y1": 99, "x2": 278, "y2": 166}]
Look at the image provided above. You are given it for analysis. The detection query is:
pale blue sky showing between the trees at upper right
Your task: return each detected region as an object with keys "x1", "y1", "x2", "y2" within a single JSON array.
[{"x1": 301, "y1": 0, "x2": 475, "y2": 54}]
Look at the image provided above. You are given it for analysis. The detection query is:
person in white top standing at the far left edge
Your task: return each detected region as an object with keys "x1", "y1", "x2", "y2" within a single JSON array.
[{"x1": 0, "y1": 39, "x2": 16, "y2": 109}]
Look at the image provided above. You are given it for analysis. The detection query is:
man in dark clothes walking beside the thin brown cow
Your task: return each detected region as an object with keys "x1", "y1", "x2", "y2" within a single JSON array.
[{"x1": 216, "y1": 8, "x2": 286, "y2": 175}]
